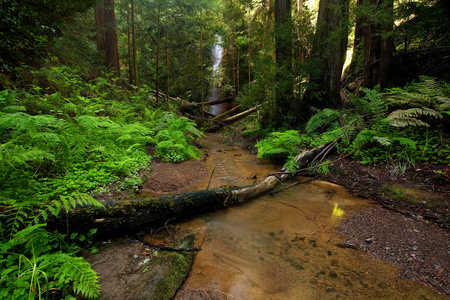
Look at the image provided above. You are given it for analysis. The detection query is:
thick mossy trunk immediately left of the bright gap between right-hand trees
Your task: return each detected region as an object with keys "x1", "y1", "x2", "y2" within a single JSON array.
[{"x1": 302, "y1": 0, "x2": 349, "y2": 118}]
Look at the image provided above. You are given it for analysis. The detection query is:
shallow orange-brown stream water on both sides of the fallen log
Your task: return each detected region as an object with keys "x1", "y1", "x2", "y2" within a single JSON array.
[{"x1": 175, "y1": 137, "x2": 446, "y2": 299}]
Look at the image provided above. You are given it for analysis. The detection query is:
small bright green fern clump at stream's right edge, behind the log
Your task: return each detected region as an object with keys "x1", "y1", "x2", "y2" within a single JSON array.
[{"x1": 255, "y1": 130, "x2": 301, "y2": 163}]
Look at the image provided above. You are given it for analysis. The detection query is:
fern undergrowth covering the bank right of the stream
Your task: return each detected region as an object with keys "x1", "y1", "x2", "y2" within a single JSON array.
[{"x1": 256, "y1": 77, "x2": 450, "y2": 172}]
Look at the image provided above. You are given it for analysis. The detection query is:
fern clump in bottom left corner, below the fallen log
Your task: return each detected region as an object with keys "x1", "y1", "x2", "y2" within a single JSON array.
[{"x1": 0, "y1": 224, "x2": 100, "y2": 299}]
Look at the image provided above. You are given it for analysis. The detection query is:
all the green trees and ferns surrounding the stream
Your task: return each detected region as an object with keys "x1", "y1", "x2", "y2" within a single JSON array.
[{"x1": 0, "y1": 0, "x2": 450, "y2": 299}]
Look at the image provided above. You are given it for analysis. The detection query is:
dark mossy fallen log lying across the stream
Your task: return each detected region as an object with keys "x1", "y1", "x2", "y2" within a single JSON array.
[{"x1": 55, "y1": 145, "x2": 326, "y2": 235}]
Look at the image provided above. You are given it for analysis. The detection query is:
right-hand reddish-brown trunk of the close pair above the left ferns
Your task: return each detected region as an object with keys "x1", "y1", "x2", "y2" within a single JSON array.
[{"x1": 104, "y1": 0, "x2": 120, "y2": 76}]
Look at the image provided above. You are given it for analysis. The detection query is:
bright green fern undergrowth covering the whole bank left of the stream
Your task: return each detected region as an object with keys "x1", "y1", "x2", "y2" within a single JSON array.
[{"x1": 0, "y1": 62, "x2": 201, "y2": 299}]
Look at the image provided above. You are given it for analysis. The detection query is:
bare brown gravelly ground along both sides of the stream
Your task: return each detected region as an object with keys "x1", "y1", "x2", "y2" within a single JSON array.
[{"x1": 85, "y1": 133, "x2": 450, "y2": 299}]
